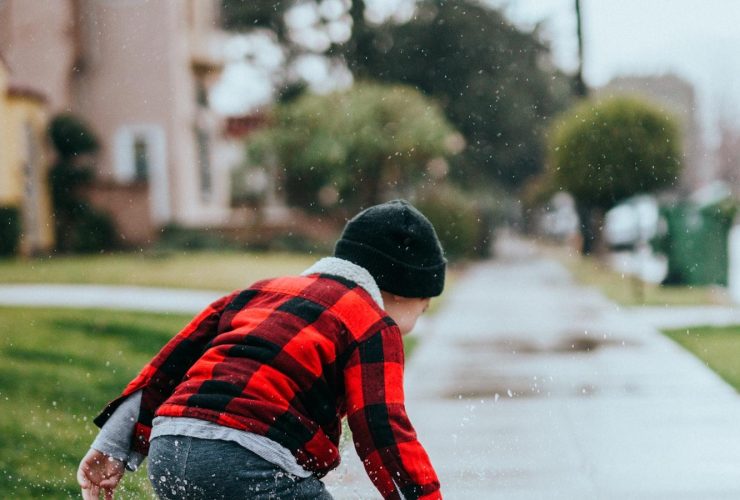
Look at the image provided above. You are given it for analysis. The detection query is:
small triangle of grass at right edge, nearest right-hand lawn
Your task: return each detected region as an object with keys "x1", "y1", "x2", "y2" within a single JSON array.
[{"x1": 663, "y1": 326, "x2": 740, "y2": 392}]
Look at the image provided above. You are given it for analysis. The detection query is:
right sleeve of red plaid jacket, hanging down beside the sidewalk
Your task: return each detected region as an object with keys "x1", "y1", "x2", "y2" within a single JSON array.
[{"x1": 345, "y1": 325, "x2": 441, "y2": 499}]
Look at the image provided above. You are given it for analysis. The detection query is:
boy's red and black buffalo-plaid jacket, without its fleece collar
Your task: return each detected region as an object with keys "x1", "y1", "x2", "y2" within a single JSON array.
[{"x1": 95, "y1": 274, "x2": 441, "y2": 499}]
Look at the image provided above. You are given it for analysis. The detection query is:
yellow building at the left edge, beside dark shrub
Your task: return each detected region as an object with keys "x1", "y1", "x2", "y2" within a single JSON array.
[{"x1": 0, "y1": 57, "x2": 54, "y2": 255}]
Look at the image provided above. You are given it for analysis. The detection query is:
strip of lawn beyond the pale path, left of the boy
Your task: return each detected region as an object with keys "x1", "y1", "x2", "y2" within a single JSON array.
[{"x1": 0, "y1": 251, "x2": 318, "y2": 291}]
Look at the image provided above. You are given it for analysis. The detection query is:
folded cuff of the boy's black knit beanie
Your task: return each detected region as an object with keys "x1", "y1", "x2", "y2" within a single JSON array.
[{"x1": 334, "y1": 239, "x2": 447, "y2": 298}]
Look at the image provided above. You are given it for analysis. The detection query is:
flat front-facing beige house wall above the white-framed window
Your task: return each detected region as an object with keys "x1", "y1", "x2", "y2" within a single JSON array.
[{"x1": 73, "y1": 0, "x2": 181, "y2": 226}]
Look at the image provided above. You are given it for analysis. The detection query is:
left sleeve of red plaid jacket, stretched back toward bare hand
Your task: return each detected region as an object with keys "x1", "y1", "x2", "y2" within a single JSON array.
[{"x1": 94, "y1": 292, "x2": 238, "y2": 455}]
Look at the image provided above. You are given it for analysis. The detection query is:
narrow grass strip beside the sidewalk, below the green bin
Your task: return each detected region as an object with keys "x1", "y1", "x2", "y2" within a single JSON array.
[{"x1": 544, "y1": 248, "x2": 729, "y2": 306}]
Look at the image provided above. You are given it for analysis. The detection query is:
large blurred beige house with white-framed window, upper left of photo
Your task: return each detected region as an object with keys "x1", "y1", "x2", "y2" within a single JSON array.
[{"x1": 0, "y1": 0, "x2": 233, "y2": 244}]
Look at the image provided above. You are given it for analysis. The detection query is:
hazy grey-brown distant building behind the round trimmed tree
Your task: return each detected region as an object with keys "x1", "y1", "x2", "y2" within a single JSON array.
[{"x1": 595, "y1": 74, "x2": 704, "y2": 193}]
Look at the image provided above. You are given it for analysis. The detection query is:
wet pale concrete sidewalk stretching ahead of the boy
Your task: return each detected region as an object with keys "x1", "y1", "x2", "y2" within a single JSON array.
[{"x1": 328, "y1": 237, "x2": 740, "y2": 500}]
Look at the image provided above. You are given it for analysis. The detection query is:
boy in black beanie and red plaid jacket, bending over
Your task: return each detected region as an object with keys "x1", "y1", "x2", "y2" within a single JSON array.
[{"x1": 77, "y1": 200, "x2": 446, "y2": 499}]
